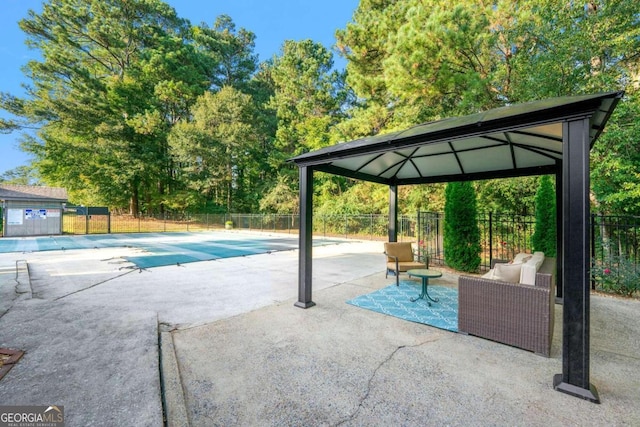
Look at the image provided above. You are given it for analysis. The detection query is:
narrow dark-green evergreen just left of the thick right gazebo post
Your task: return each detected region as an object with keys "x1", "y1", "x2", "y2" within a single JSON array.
[{"x1": 531, "y1": 175, "x2": 557, "y2": 257}]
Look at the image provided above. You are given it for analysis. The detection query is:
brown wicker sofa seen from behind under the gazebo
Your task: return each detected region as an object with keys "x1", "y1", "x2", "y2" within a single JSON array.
[{"x1": 458, "y1": 258, "x2": 556, "y2": 357}]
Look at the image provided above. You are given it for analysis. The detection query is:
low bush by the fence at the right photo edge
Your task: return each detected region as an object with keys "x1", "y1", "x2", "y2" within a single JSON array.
[{"x1": 591, "y1": 256, "x2": 640, "y2": 297}]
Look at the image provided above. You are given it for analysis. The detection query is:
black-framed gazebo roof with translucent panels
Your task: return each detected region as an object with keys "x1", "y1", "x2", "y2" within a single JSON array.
[{"x1": 290, "y1": 91, "x2": 623, "y2": 185}]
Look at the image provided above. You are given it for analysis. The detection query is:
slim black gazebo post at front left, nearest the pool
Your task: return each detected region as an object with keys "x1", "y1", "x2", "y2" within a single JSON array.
[{"x1": 294, "y1": 166, "x2": 316, "y2": 308}]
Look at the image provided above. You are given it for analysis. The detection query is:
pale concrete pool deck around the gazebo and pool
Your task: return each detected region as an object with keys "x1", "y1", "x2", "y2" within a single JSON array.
[{"x1": 0, "y1": 232, "x2": 640, "y2": 426}]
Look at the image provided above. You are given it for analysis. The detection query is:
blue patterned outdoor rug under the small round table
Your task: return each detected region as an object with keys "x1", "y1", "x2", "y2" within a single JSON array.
[{"x1": 347, "y1": 281, "x2": 458, "y2": 332}]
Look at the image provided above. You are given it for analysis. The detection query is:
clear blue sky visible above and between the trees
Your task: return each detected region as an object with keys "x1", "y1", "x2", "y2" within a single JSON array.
[{"x1": 0, "y1": 0, "x2": 359, "y2": 174}]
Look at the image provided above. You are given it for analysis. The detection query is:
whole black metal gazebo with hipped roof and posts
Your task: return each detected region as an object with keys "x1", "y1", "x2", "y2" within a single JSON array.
[{"x1": 290, "y1": 92, "x2": 623, "y2": 403}]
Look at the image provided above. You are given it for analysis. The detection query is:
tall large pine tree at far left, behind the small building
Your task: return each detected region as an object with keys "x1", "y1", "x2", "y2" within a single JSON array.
[{"x1": 3, "y1": 0, "x2": 211, "y2": 214}]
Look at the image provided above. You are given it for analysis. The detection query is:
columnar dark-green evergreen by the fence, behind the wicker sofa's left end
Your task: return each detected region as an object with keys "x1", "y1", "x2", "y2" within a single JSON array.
[{"x1": 444, "y1": 182, "x2": 481, "y2": 272}]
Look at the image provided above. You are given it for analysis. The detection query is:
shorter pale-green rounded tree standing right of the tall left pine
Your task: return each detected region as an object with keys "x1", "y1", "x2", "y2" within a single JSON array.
[{"x1": 169, "y1": 86, "x2": 261, "y2": 212}]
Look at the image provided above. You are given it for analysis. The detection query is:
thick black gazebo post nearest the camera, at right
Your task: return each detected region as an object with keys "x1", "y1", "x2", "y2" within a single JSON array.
[{"x1": 553, "y1": 117, "x2": 600, "y2": 403}]
